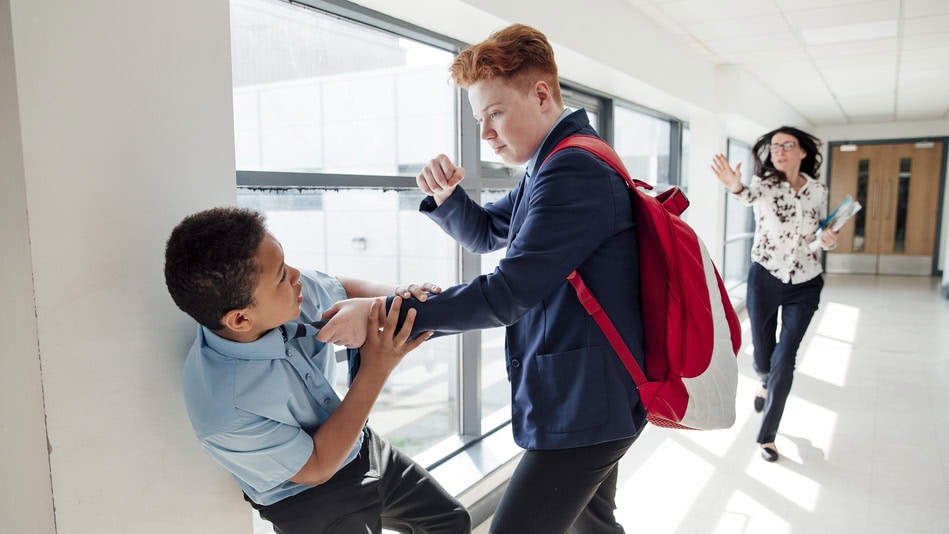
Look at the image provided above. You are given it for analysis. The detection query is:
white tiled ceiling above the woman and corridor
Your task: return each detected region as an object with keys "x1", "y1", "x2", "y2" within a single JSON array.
[{"x1": 627, "y1": 0, "x2": 949, "y2": 126}]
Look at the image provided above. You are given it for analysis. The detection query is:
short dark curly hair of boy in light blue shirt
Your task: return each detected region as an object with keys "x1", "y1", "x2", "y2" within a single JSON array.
[{"x1": 165, "y1": 208, "x2": 267, "y2": 330}]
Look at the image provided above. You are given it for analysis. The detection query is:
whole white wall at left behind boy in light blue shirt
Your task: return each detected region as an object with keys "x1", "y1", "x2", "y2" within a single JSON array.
[{"x1": 0, "y1": 0, "x2": 250, "y2": 534}]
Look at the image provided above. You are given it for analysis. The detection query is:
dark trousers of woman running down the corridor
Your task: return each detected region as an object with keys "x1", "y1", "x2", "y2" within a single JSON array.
[{"x1": 747, "y1": 263, "x2": 824, "y2": 443}]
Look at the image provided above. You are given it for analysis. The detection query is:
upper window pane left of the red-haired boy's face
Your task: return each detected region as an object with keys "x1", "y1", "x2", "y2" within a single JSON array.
[{"x1": 231, "y1": 0, "x2": 455, "y2": 176}]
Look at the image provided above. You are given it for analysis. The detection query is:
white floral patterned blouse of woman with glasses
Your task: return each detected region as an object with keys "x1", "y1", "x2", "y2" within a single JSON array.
[{"x1": 735, "y1": 174, "x2": 827, "y2": 284}]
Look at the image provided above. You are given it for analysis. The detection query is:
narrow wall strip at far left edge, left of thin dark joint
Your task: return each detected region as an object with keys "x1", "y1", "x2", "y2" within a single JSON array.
[{"x1": 0, "y1": 0, "x2": 53, "y2": 532}]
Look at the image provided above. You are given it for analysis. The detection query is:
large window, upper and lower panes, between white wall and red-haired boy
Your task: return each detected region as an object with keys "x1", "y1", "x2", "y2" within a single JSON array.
[{"x1": 231, "y1": 0, "x2": 460, "y2": 455}]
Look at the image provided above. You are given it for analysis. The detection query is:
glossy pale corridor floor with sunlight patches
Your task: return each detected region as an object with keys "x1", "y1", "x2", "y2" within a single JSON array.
[{"x1": 596, "y1": 275, "x2": 949, "y2": 534}]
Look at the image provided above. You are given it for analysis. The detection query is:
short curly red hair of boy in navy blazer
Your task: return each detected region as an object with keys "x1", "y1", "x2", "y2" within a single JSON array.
[{"x1": 451, "y1": 24, "x2": 563, "y2": 104}]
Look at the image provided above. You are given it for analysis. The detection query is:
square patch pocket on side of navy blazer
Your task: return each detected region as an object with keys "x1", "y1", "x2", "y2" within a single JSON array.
[{"x1": 528, "y1": 347, "x2": 609, "y2": 433}]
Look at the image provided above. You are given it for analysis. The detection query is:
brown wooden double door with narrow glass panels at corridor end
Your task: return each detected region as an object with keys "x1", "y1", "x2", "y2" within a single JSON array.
[{"x1": 826, "y1": 142, "x2": 943, "y2": 276}]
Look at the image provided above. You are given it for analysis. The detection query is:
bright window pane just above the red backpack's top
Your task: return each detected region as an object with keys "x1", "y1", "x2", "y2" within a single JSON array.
[{"x1": 613, "y1": 106, "x2": 671, "y2": 185}]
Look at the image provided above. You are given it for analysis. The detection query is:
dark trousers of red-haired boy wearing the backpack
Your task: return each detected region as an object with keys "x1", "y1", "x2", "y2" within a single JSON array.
[{"x1": 489, "y1": 438, "x2": 636, "y2": 534}]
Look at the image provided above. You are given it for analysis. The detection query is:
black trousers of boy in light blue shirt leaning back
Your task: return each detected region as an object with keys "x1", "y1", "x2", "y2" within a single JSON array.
[{"x1": 245, "y1": 427, "x2": 471, "y2": 534}]
